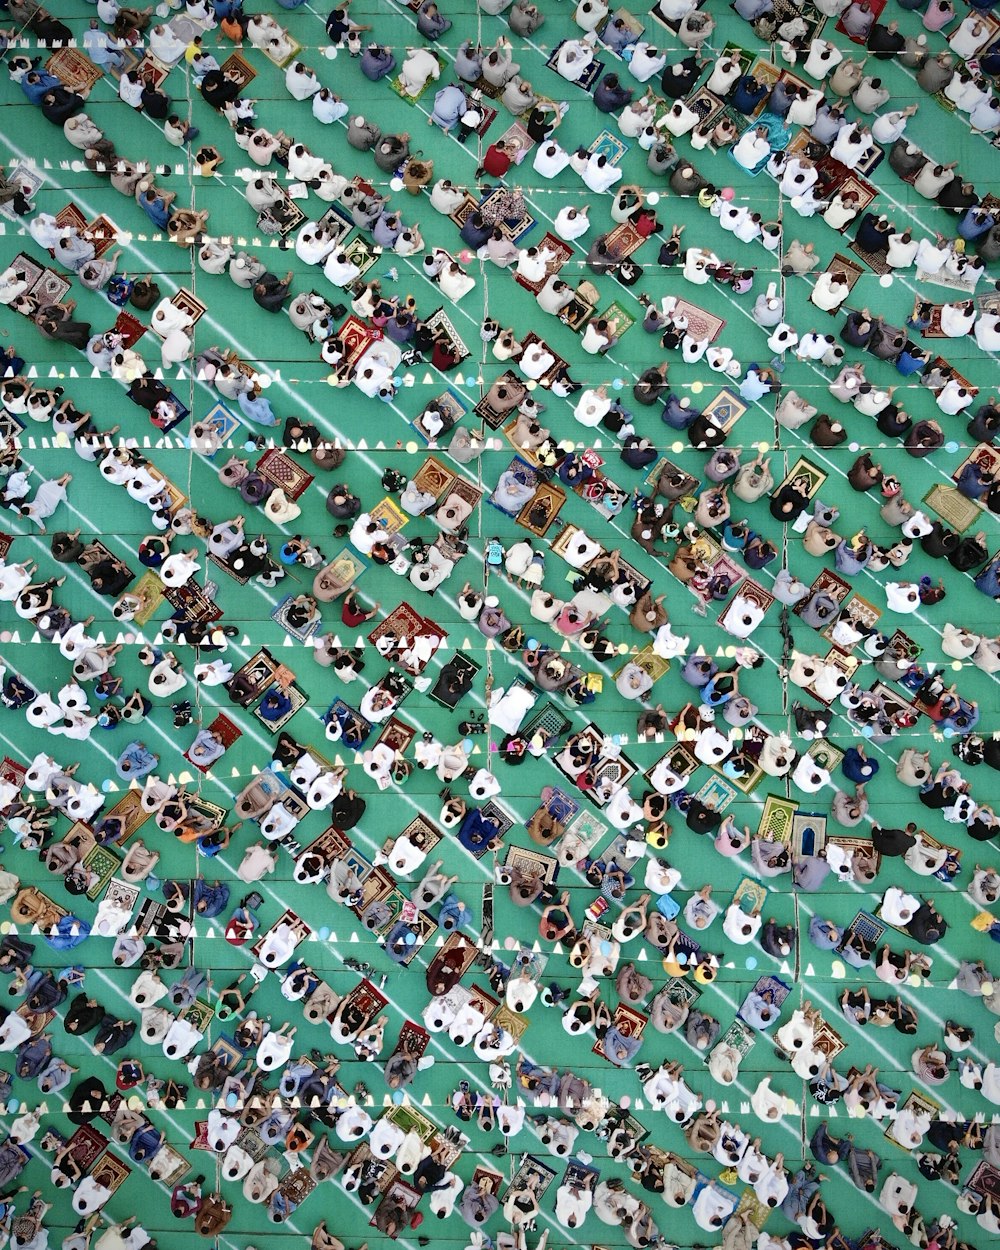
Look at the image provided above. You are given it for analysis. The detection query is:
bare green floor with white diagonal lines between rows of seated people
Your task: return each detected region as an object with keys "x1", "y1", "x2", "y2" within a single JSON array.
[{"x1": 0, "y1": 0, "x2": 1000, "y2": 1250}]
